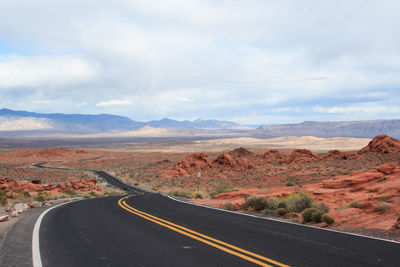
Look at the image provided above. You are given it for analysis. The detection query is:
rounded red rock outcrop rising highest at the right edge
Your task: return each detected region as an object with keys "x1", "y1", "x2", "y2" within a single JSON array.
[{"x1": 358, "y1": 134, "x2": 400, "y2": 154}]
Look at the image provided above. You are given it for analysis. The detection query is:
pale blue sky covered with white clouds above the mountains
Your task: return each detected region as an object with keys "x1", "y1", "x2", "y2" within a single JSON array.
[{"x1": 0, "y1": 0, "x2": 400, "y2": 125}]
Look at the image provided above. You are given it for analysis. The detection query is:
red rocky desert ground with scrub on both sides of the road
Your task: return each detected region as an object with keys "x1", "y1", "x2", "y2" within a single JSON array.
[{"x1": 0, "y1": 135, "x2": 400, "y2": 241}]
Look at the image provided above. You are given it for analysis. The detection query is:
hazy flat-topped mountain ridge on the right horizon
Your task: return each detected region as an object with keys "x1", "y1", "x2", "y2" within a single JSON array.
[{"x1": 248, "y1": 120, "x2": 400, "y2": 138}]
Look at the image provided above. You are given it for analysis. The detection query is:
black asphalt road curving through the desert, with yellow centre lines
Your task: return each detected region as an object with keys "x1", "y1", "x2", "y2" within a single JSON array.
[{"x1": 39, "y1": 172, "x2": 400, "y2": 267}]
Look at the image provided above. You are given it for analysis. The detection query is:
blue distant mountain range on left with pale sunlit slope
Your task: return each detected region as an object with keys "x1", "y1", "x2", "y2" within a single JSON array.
[{"x1": 0, "y1": 108, "x2": 245, "y2": 134}]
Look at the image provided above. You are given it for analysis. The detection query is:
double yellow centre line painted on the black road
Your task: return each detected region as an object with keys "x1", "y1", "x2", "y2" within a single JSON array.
[{"x1": 118, "y1": 195, "x2": 289, "y2": 267}]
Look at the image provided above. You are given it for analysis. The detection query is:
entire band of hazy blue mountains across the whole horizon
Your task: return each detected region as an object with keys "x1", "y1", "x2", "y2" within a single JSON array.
[{"x1": 0, "y1": 108, "x2": 400, "y2": 138}]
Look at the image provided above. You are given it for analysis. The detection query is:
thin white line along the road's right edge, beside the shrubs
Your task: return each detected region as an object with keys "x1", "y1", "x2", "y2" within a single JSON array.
[{"x1": 161, "y1": 194, "x2": 400, "y2": 244}]
